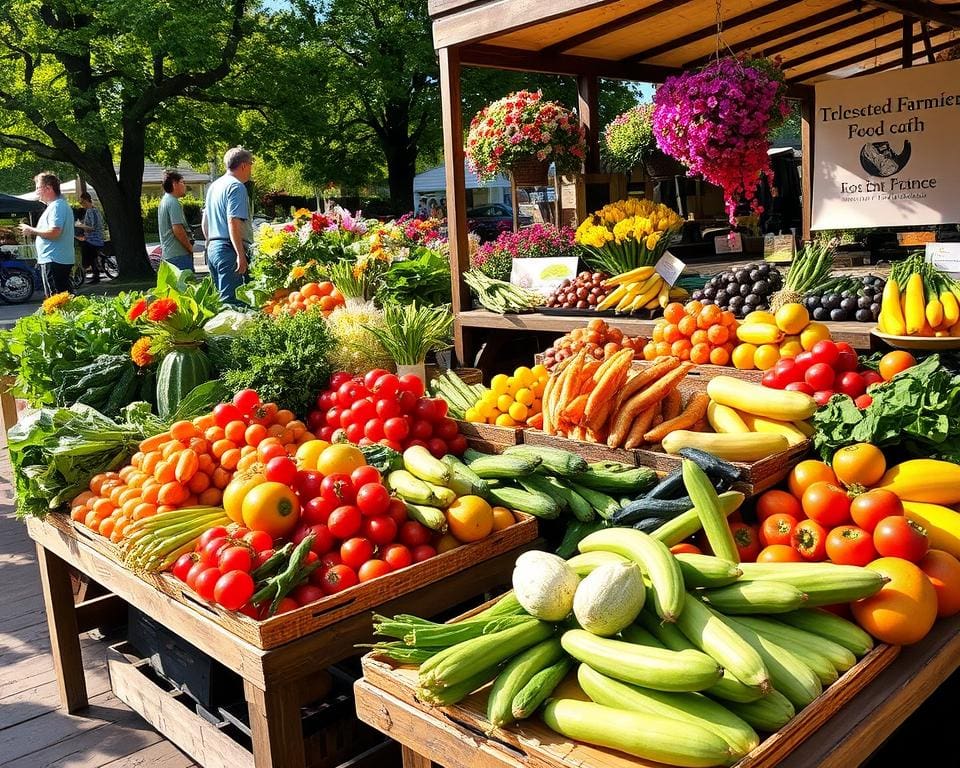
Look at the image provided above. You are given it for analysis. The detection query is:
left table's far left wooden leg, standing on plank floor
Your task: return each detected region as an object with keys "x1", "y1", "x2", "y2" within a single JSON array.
[{"x1": 37, "y1": 544, "x2": 87, "y2": 713}]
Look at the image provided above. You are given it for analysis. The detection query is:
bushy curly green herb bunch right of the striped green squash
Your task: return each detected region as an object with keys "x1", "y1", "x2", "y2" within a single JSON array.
[{"x1": 223, "y1": 309, "x2": 334, "y2": 415}]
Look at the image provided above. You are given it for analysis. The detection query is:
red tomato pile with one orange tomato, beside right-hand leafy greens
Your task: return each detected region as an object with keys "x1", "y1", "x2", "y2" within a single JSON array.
[{"x1": 762, "y1": 339, "x2": 916, "y2": 408}]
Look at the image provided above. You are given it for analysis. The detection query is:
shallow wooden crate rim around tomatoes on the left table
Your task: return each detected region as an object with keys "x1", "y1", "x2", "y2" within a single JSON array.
[{"x1": 46, "y1": 512, "x2": 537, "y2": 650}]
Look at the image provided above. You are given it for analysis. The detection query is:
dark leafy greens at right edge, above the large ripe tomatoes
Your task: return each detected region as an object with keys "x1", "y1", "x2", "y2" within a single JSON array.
[{"x1": 813, "y1": 355, "x2": 960, "y2": 462}]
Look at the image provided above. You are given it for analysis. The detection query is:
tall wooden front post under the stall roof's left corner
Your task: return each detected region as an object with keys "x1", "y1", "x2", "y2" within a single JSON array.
[{"x1": 438, "y1": 48, "x2": 470, "y2": 365}]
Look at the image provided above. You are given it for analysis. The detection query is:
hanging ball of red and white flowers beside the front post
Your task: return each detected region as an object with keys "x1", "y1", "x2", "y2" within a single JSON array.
[{"x1": 465, "y1": 91, "x2": 586, "y2": 181}]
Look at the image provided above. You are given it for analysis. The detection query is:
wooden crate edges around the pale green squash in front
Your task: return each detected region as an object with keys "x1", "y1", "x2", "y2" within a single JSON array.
[{"x1": 355, "y1": 616, "x2": 900, "y2": 768}]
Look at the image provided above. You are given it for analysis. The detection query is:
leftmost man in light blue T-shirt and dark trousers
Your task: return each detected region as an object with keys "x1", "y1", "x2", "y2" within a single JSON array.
[{"x1": 20, "y1": 171, "x2": 76, "y2": 296}]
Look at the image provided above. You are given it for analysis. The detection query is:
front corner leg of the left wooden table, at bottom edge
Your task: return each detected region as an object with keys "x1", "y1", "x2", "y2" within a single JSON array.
[{"x1": 243, "y1": 680, "x2": 306, "y2": 768}]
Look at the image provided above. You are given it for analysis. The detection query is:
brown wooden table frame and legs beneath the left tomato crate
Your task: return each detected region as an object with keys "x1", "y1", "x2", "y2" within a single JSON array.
[{"x1": 27, "y1": 519, "x2": 535, "y2": 768}]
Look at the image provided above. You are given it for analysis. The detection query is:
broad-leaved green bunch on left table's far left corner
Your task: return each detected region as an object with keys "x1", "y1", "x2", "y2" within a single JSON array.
[{"x1": 7, "y1": 403, "x2": 162, "y2": 518}]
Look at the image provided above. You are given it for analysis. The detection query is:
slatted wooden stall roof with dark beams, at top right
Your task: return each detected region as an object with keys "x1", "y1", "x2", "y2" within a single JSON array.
[{"x1": 429, "y1": 0, "x2": 960, "y2": 84}]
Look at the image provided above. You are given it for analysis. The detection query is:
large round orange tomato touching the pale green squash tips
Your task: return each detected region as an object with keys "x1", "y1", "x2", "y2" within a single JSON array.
[{"x1": 850, "y1": 557, "x2": 937, "y2": 645}]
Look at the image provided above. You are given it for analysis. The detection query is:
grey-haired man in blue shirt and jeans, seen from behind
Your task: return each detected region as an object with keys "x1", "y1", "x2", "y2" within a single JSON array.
[{"x1": 201, "y1": 147, "x2": 253, "y2": 304}]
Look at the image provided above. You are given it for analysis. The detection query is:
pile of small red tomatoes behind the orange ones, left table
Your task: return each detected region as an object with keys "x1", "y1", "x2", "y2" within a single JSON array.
[{"x1": 307, "y1": 368, "x2": 467, "y2": 459}]
